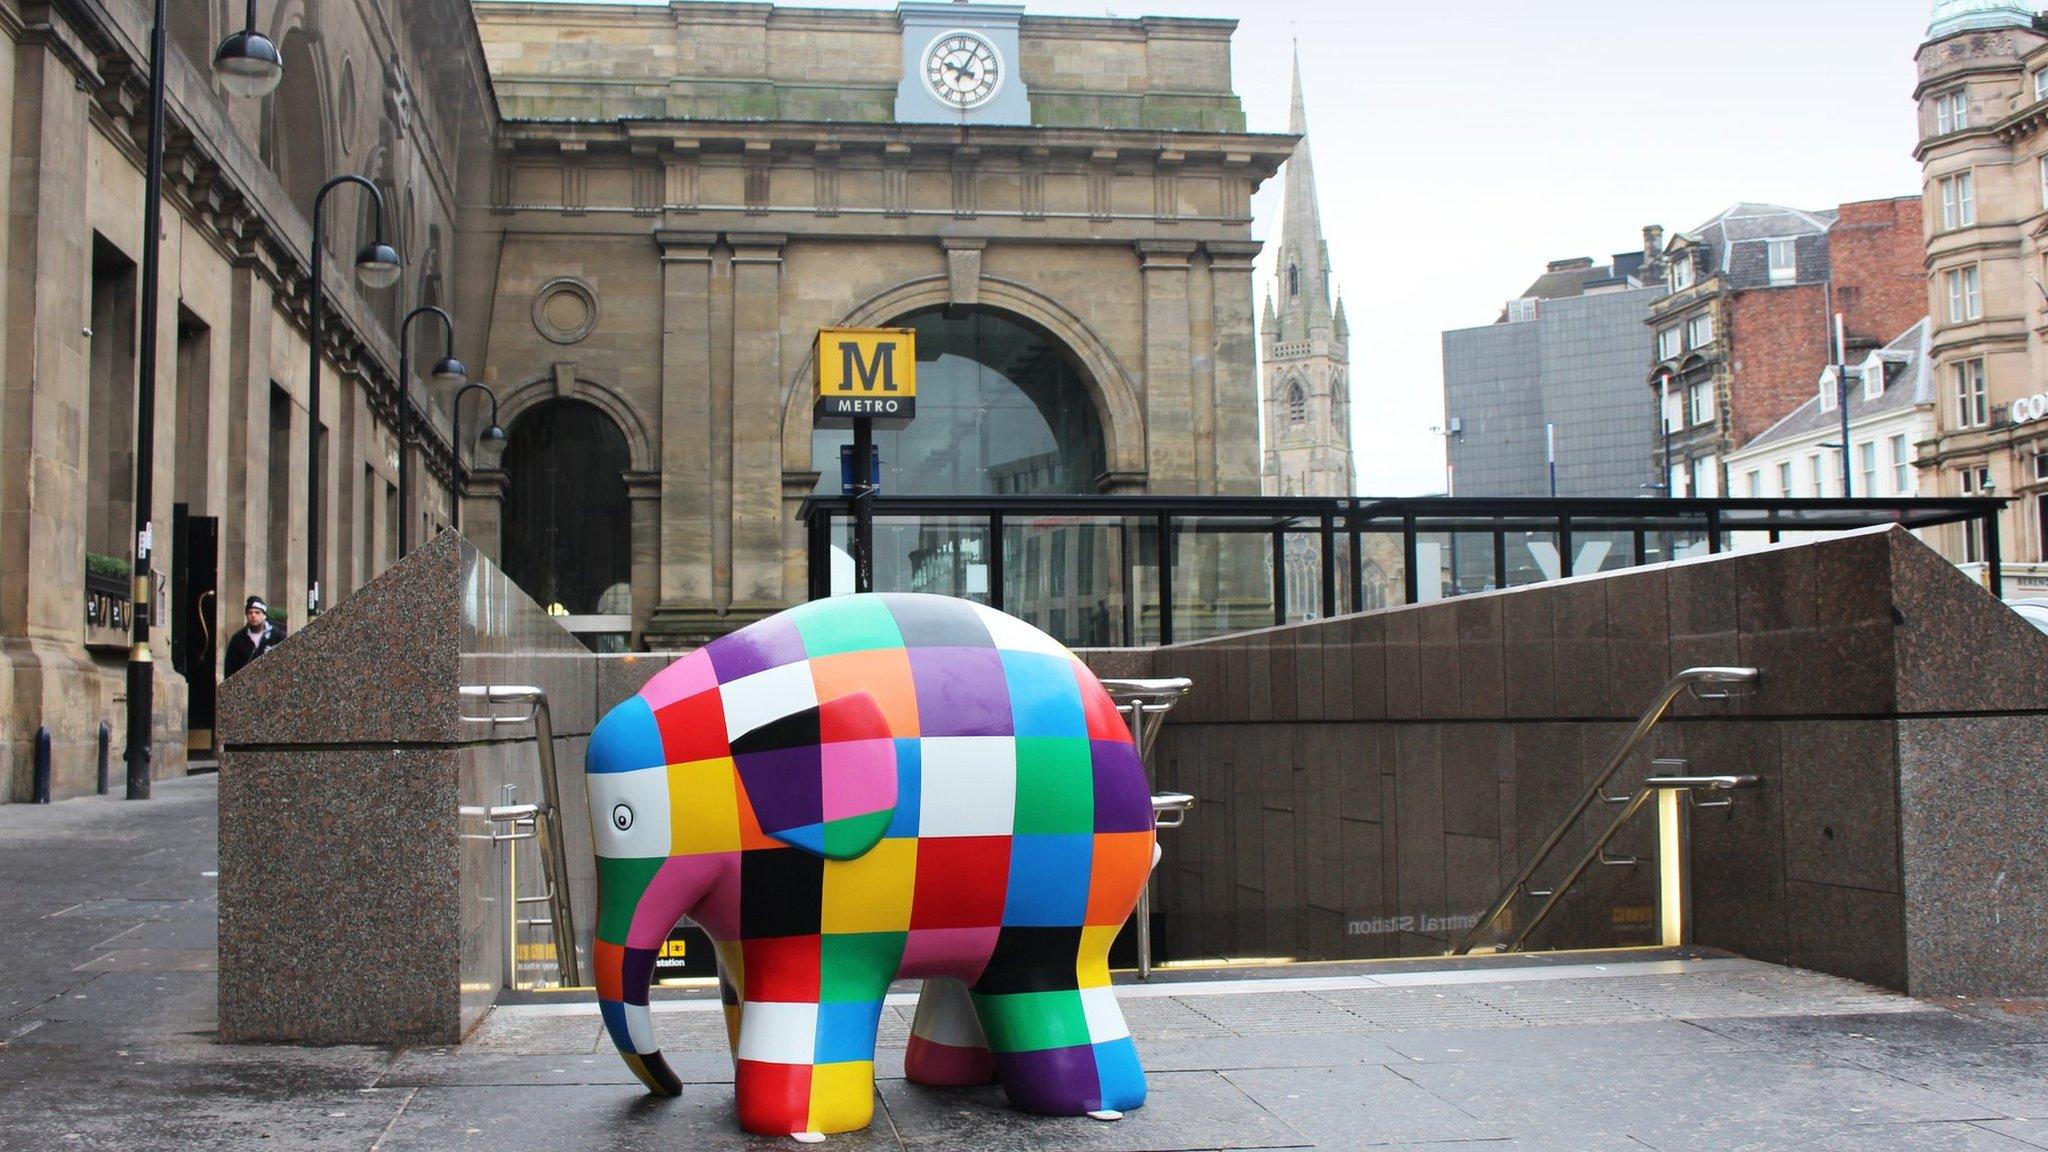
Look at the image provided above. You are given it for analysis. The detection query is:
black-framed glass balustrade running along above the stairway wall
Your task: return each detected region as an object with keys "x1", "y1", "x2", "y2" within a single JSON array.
[{"x1": 797, "y1": 494, "x2": 2005, "y2": 648}]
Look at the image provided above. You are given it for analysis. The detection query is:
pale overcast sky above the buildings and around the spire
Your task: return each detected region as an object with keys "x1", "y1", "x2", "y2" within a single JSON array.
[{"x1": 569, "y1": 0, "x2": 1933, "y2": 487}]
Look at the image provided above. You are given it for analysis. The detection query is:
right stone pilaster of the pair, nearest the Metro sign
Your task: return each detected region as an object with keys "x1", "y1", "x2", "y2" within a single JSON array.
[{"x1": 727, "y1": 234, "x2": 788, "y2": 627}]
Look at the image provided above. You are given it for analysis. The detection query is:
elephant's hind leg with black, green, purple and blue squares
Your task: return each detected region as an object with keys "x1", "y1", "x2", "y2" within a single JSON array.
[{"x1": 973, "y1": 929, "x2": 1145, "y2": 1115}]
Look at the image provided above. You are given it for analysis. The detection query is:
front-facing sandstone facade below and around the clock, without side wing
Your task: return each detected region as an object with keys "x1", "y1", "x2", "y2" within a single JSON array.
[{"x1": 471, "y1": 2, "x2": 1292, "y2": 646}]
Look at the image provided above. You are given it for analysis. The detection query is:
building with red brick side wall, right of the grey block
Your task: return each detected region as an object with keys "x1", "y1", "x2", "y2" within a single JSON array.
[{"x1": 1649, "y1": 197, "x2": 1925, "y2": 496}]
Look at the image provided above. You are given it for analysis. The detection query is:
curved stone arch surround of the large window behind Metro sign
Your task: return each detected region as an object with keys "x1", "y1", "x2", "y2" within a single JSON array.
[{"x1": 782, "y1": 277, "x2": 1145, "y2": 478}]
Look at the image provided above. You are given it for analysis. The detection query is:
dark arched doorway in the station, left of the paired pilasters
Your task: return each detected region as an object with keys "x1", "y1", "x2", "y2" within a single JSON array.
[{"x1": 504, "y1": 400, "x2": 633, "y2": 615}]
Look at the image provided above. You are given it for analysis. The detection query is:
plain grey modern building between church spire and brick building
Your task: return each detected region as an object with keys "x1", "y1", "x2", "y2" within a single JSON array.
[{"x1": 1444, "y1": 247, "x2": 1665, "y2": 496}]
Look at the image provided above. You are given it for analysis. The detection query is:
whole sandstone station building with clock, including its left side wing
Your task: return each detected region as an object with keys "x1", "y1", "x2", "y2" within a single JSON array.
[{"x1": 0, "y1": 0, "x2": 1292, "y2": 799}]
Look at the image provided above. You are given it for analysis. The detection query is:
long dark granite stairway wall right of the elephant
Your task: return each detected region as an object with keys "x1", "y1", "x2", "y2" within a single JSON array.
[{"x1": 1090, "y1": 529, "x2": 2048, "y2": 994}]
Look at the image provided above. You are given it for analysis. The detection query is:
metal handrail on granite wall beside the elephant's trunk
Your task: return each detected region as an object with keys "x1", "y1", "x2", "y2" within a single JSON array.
[{"x1": 461, "y1": 685, "x2": 584, "y2": 988}]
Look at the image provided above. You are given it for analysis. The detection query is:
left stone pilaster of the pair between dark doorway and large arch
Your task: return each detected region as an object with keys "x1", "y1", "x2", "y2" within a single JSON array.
[{"x1": 663, "y1": 232, "x2": 717, "y2": 610}]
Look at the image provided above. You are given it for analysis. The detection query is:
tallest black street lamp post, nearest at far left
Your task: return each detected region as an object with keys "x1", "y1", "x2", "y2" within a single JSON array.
[{"x1": 127, "y1": 0, "x2": 285, "y2": 799}]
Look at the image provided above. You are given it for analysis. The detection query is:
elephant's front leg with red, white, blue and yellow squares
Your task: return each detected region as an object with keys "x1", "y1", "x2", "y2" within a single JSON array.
[{"x1": 733, "y1": 933, "x2": 903, "y2": 1136}]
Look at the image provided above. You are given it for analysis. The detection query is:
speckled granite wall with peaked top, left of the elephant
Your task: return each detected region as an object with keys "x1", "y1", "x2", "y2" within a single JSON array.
[{"x1": 219, "y1": 533, "x2": 600, "y2": 1043}]
